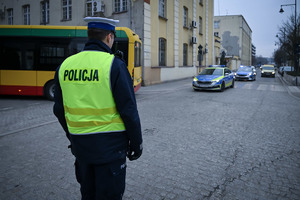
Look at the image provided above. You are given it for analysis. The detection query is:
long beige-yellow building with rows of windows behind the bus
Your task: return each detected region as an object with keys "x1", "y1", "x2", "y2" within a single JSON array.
[{"x1": 0, "y1": 0, "x2": 220, "y2": 85}]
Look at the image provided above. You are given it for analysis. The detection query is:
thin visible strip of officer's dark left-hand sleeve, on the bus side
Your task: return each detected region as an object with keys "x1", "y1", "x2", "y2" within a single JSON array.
[{"x1": 53, "y1": 67, "x2": 70, "y2": 139}]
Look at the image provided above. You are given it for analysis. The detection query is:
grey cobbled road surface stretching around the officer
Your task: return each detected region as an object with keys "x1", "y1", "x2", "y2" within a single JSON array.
[{"x1": 0, "y1": 71, "x2": 300, "y2": 200}]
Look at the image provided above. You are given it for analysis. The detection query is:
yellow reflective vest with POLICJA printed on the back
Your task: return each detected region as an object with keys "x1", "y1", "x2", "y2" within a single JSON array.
[{"x1": 59, "y1": 51, "x2": 125, "y2": 134}]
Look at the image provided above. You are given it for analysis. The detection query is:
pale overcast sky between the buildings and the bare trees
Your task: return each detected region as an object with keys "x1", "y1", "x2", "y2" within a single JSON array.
[{"x1": 214, "y1": 0, "x2": 300, "y2": 57}]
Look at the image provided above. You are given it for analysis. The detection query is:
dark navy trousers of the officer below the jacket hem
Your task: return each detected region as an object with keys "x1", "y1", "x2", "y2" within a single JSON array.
[{"x1": 75, "y1": 158, "x2": 126, "y2": 200}]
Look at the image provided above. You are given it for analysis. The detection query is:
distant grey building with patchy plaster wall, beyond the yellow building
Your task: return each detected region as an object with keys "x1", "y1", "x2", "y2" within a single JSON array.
[{"x1": 214, "y1": 15, "x2": 252, "y2": 69}]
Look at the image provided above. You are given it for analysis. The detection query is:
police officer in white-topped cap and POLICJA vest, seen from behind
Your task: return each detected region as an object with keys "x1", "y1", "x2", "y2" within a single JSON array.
[{"x1": 53, "y1": 17, "x2": 143, "y2": 200}]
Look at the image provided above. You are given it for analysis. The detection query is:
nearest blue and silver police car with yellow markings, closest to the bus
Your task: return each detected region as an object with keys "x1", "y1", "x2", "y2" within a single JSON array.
[{"x1": 193, "y1": 65, "x2": 234, "y2": 91}]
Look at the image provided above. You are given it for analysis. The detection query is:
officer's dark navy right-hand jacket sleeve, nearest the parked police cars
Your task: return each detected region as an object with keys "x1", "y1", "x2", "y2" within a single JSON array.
[{"x1": 111, "y1": 58, "x2": 143, "y2": 151}]
